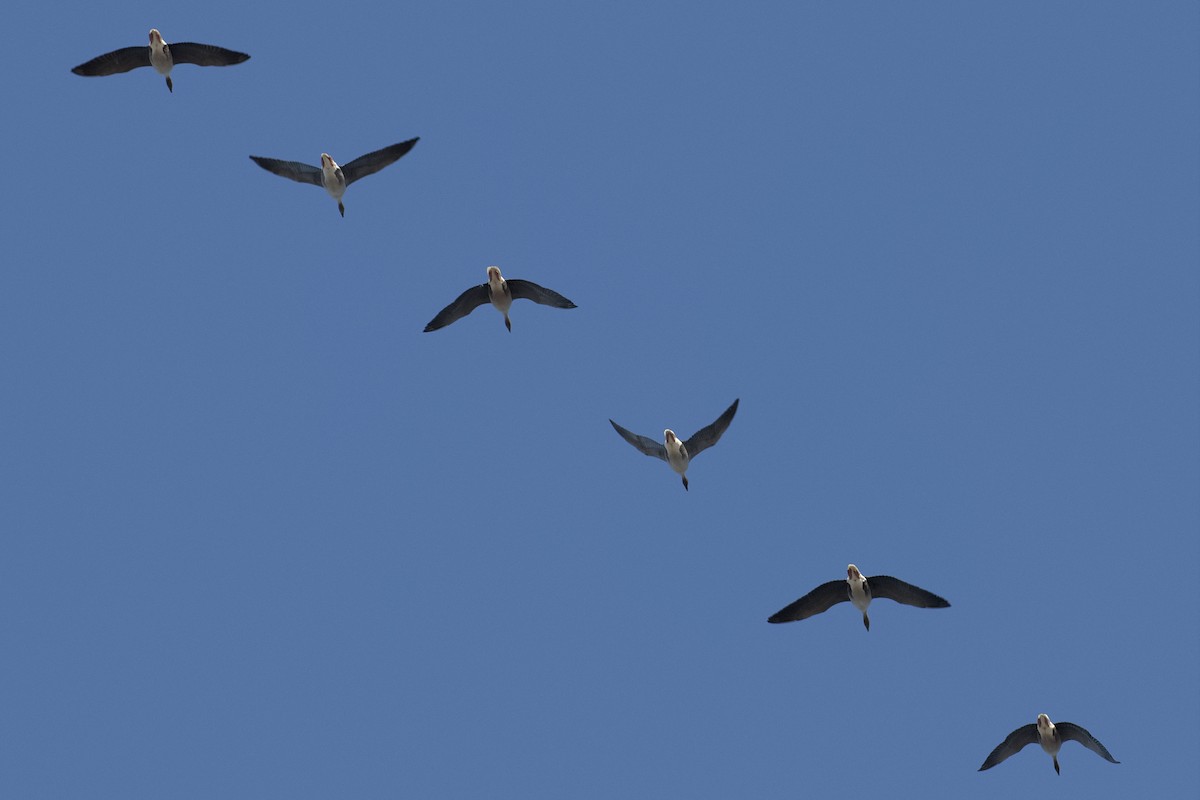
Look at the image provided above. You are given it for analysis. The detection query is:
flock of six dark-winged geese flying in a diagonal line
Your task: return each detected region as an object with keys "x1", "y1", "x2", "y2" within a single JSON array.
[{"x1": 71, "y1": 29, "x2": 1120, "y2": 772}]
